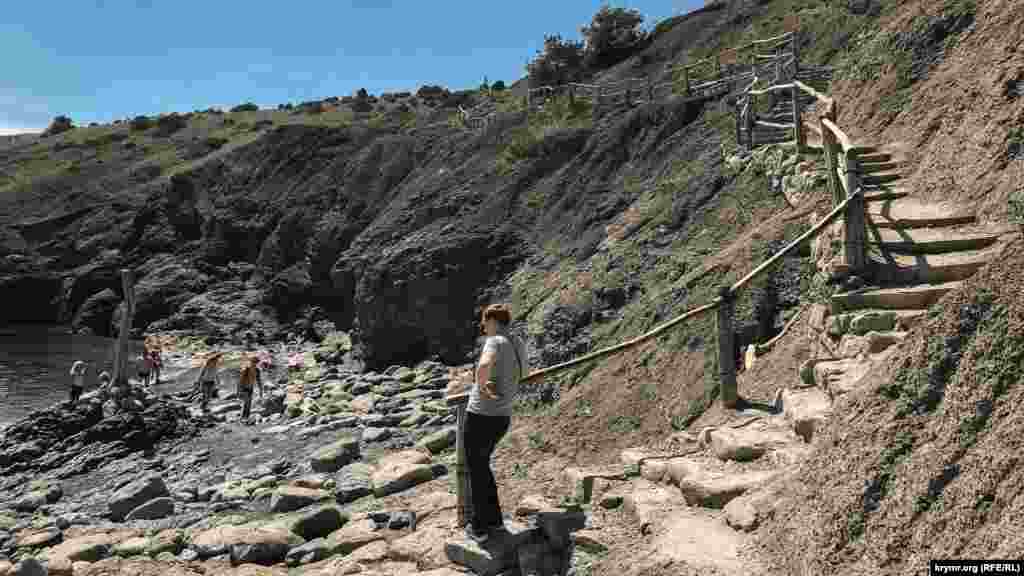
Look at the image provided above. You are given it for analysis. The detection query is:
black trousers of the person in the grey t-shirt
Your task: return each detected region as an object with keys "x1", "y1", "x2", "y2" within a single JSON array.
[{"x1": 465, "y1": 412, "x2": 512, "y2": 530}]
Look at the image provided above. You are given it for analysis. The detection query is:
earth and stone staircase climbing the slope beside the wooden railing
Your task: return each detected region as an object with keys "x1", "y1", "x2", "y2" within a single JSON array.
[{"x1": 565, "y1": 68, "x2": 1018, "y2": 575}]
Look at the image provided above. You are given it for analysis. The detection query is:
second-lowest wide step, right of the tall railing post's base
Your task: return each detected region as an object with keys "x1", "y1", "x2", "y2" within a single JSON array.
[{"x1": 868, "y1": 243, "x2": 1004, "y2": 286}]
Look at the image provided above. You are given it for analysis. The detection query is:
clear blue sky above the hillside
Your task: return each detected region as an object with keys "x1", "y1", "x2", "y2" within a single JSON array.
[{"x1": 0, "y1": 0, "x2": 703, "y2": 131}]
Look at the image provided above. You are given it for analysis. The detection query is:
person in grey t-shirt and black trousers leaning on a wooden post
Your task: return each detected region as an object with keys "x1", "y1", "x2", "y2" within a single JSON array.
[{"x1": 465, "y1": 304, "x2": 526, "y2": 542}]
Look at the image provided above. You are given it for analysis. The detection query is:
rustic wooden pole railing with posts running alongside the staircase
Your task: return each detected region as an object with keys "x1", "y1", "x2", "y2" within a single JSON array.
[{"x1": 446, "y1": 33, "x2": 866, "y2": 526}]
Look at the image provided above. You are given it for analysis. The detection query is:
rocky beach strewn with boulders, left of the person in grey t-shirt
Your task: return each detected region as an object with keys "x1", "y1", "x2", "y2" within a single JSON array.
[{"x1": 0, "y1": 336, "x2": 589, "y2": 576}]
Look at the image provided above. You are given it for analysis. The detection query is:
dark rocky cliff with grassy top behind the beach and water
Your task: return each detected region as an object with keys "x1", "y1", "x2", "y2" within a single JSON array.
[{"x1": 0, "y1": 0, "x2": 770, "y2": 366}]
